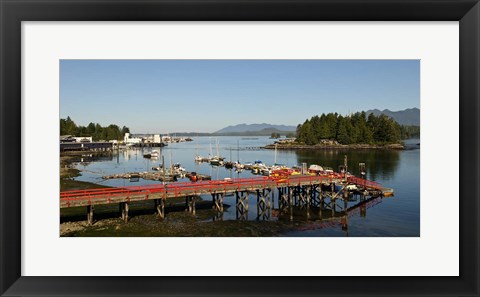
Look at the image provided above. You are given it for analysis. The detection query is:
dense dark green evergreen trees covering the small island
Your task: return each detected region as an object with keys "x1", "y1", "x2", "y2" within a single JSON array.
[{"x1": 296, "y1": 112, "x2": 420, "y2": 145}]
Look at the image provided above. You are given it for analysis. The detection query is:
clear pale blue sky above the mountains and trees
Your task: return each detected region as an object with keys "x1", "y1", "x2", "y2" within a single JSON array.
[{"x1": 60, "y1": 60, "x2": 420, "y2": 133}]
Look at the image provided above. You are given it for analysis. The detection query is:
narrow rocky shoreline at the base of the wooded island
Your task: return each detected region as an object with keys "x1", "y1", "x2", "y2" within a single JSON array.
[{"x1": 262, "y1": 143, "x2": 405, "y2": 150}]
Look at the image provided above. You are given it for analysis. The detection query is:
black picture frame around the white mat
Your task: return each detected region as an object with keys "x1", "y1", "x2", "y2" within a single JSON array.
[{"x1": 0, "y1": 0, "x2": 480, "y2": 296}]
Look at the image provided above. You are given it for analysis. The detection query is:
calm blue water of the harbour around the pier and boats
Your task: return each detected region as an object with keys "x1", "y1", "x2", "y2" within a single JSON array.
[{"x1": 69, "y1": 137, "x2": 420, "y2": 237}]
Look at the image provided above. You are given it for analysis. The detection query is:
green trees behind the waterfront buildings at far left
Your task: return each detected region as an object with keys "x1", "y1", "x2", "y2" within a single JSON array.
[{"x1": 60, "y1": 117, "x2": 130, "y2": 141}]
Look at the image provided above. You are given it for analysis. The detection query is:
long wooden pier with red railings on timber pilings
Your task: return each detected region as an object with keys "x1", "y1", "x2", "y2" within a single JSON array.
[{"x1": 60, "y1": 175, "x2": 393, "y2": 224}]
